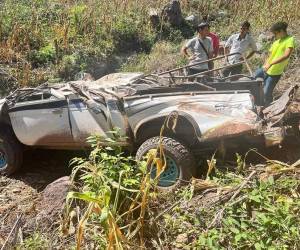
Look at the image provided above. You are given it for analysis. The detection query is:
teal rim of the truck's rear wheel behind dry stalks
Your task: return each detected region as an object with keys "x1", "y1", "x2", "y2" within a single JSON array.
[{"x1": 151, "y1": 156, "x2": 180, "y2": 187}]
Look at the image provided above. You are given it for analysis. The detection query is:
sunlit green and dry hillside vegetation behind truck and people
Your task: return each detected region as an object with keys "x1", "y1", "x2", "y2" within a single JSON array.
[{"x1": 0, "y1": 0, "x2": 300, "y2": 89}]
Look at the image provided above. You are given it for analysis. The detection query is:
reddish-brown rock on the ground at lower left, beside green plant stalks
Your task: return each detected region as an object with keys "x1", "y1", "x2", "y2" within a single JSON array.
[{"x1": 36, "y1": 176, "x2": 71, "y2": 228}]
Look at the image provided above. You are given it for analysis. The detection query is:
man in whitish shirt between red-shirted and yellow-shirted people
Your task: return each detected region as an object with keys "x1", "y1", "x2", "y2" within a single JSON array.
[{"x1": 223, "y1": 21, "x2": 257, "y2": 77}]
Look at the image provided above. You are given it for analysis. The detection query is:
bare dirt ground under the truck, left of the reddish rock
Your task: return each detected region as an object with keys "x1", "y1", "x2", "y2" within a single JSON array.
[{"x1": 0, "y1": 150, "x2": 84, "y2": 246}]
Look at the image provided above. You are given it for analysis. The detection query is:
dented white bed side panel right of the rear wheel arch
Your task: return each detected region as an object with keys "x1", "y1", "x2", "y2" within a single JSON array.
[{"x1": 161, "y1": 94, "x2": 258, "y2": 141}]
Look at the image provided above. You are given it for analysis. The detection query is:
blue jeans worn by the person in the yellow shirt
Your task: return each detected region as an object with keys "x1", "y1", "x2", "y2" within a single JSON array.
[{"x1": 254, "y1": 68, "x2": 281, "y2": 106}]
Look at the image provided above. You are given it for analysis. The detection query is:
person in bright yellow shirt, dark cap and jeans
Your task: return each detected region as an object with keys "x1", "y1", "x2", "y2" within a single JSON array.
[{"x1": 255, "y1": 22, "x2": 295, "y2": 105}]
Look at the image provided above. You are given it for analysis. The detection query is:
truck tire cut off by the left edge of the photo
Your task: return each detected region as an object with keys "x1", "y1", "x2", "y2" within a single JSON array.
[{"x1": 0, "y1": 126, "x2": 23, "y2": 175}]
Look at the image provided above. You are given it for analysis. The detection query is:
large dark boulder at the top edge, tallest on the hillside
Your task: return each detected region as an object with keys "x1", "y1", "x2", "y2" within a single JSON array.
[{"x1": 162, "y1": 0, "x2": 184, "y2": 26}]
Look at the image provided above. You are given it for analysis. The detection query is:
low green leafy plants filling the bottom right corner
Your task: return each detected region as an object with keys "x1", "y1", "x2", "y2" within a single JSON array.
[{"x1": 196, "y1": 177, "x2": 300, "y2": 249}]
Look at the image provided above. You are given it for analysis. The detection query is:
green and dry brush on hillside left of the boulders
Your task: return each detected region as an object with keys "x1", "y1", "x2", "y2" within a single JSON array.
[{"x1": 0, "y1": 0, "x2": 188, "y2": 85}]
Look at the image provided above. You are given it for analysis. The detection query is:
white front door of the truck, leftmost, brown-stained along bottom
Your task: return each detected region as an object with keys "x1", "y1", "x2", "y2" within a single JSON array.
[{"x1": 9, "y1": 92, "x2": 73, "y2": 147}]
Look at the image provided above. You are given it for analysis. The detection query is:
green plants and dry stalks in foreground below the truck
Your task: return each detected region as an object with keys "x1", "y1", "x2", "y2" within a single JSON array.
[{"x1": 63, "y1": 136, "x2": 300, "y2": 249}]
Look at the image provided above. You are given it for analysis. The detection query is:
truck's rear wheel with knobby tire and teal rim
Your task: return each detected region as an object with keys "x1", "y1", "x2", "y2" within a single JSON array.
[{"x1": 136, "y1": 137, "x2": 196, "y2": 190}]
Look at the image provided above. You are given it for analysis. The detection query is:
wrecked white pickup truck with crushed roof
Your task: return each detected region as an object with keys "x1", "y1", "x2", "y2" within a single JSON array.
[{"x1": 0, "y1": 73, "x2": 300, "y2": 188}]
